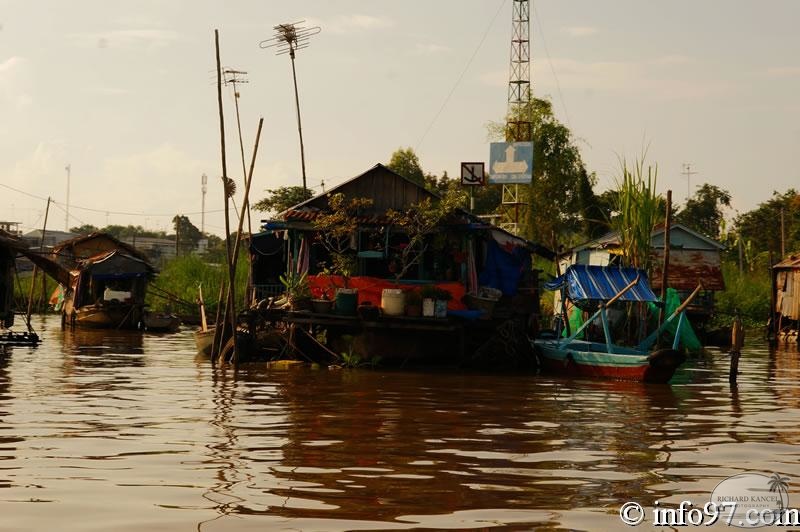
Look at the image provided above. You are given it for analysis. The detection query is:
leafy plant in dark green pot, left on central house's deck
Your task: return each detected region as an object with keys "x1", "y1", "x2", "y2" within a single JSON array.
[{"x1": 314, "y1": 193, "x2": 372, "y2": 315}]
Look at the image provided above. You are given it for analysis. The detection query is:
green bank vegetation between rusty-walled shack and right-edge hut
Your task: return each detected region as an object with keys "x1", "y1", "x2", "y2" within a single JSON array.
[{"x1": 715, "y1": 261, "x2": 772, "y2": 327}]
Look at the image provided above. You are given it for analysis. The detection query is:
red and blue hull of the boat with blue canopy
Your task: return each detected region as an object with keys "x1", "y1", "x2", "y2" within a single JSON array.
[{"x1": 534, "y1": 339, "x2": 686, "y2": 383}]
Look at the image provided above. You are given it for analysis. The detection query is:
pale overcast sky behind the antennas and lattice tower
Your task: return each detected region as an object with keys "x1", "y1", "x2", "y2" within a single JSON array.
[{"x1": 0, "y1": 0, "x2": 800, "y2": 235}]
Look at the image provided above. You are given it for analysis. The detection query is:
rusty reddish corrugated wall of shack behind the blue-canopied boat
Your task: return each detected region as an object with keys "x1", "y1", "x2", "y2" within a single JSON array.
[{"x1": 652, "y1": 249, "x2": 725, "y2": 290}]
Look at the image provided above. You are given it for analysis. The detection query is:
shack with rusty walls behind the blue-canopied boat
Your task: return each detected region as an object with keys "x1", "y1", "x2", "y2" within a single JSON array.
[{"x1": 555, "y1": 224, "x2": 725, "y2": 327}]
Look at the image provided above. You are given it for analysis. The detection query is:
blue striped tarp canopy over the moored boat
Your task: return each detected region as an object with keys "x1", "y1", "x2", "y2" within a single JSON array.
[{"x1": 544, "y1": 264, "x2": 659, "y2": 302}]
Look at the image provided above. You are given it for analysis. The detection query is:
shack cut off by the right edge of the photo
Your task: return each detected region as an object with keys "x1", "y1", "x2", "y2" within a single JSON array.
[{"x1": 770, "y1": 253, "x2": 800, "y2": 342}]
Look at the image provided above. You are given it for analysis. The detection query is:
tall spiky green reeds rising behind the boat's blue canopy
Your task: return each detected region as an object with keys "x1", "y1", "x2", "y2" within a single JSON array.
[{"x1": 611, "y1": 154, "x2": 665, "y2": 271}]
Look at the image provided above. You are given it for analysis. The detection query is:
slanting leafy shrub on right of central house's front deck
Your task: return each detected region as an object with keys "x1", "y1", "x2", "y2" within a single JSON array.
[{"x1": 386, "y1": 188, "x2": 465, "y2": 281}]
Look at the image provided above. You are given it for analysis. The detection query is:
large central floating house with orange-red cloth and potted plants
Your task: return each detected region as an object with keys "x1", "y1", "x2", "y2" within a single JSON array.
[{"x1": 245, "y1": 164, "x2": 553, "y2": 365}]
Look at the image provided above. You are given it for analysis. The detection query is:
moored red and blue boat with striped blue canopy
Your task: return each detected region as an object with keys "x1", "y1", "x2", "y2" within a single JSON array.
[{"x1": 533, "y1": 265, "x2": 699, "y2": 383}]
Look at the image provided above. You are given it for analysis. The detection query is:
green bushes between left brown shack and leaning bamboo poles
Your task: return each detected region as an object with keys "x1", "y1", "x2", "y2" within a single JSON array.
[{"x1": 145, "y1": 250, "x2": 248, "y2": 313}]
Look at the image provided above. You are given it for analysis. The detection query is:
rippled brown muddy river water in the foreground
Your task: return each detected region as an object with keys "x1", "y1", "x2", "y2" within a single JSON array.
[{"x1": 0, "y1": 318, "x2": 800, "y2": 531}]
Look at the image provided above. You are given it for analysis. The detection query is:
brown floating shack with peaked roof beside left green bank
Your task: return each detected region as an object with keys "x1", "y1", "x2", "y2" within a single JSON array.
[{"x1": 52, "y1": 233, "x2": 155, "y2": 329}]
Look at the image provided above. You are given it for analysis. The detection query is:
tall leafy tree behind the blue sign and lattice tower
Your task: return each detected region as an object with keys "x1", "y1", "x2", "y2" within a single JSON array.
[{"x1": 487, "y1": 98, "x2": 591, "y2": 243}]
